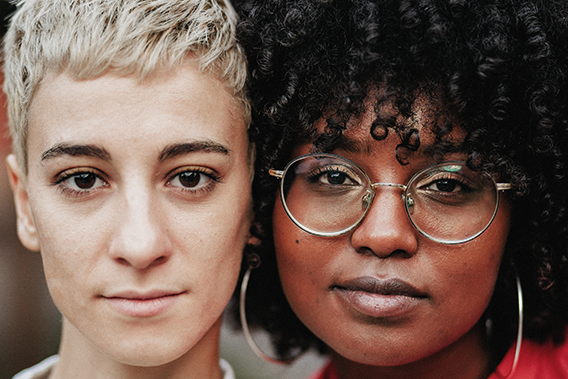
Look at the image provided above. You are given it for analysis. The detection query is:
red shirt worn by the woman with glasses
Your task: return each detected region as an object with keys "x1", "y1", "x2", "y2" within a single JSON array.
[{"x1": 310, "y1": 339, "x2": 568, "y2": 379}]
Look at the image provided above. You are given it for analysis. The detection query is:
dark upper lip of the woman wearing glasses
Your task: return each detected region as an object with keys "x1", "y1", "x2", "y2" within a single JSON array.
[{"x1": 332, "y1": 276, "x2": 427, "y2": 298}]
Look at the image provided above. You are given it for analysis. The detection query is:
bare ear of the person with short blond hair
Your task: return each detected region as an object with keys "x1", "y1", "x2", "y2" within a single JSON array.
[{"x1": 6, "y1": 154, "x2": 39, "y2": 251}]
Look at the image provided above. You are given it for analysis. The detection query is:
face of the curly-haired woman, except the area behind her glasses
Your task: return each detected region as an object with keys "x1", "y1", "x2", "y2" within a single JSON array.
[{"x1": 274, "y1": 109, "x2": 509, "y2": 366}]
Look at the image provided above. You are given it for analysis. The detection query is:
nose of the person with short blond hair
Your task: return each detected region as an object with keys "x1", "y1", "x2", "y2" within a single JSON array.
[{"x1": 109, "y1": 188, "x2": 172, "y2": 270}]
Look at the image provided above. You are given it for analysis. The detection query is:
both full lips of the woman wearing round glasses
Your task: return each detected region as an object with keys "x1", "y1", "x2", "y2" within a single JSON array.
[{"x1": 331, "y1": 276, "x2": 428, "y2": 318}]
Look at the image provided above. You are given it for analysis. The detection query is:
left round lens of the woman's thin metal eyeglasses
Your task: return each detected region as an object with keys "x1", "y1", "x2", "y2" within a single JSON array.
[{"x1": 280, "y1": 154, "x2": 372, "y2": 236}]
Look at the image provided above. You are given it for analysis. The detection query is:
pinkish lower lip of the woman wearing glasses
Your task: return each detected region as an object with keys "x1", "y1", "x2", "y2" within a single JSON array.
[{"x1": 336, "y1": 289, "x2": 424, "y2": 318}]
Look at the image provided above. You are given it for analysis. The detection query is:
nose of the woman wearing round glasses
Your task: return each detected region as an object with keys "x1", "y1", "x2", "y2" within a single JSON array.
[{"x1": 351, "y1": 186, "x2": 418, "y2": 258}]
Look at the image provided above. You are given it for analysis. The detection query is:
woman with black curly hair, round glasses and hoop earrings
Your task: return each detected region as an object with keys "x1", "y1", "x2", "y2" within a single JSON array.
[{"x1": 233, "y1": 0, "x2": 568, "y2": 379}]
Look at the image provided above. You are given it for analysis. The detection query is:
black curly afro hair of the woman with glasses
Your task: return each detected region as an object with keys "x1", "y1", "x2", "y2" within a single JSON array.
[{"x1": 229, "y1": 0, "x2": 568, "y2": 366}]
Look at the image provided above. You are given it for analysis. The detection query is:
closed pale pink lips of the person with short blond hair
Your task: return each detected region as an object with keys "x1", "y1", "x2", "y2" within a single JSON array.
[{"x1": 102, "y1": 291, "x2": 185, "y2": 318}]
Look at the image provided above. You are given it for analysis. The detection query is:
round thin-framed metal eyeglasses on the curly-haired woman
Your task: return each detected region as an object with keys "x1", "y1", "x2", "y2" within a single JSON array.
[{"x1": 269, "y1": 153, "x2": 512, "y2": 245}]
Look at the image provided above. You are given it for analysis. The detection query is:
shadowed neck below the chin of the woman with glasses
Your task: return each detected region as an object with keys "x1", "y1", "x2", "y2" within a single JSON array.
[{"x1": 331, "y1": 326, "x2": 493, "y2": 379}]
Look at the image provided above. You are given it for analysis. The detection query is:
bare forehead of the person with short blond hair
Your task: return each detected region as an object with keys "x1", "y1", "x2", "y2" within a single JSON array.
[{"x1": 27, "y1": 63, "x2": 248, "y2": 165}]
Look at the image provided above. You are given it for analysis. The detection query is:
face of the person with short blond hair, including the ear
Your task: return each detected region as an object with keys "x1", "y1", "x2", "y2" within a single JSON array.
[{"x1": 9, "y1": 63, "x2": 251, "y2": 366}]
